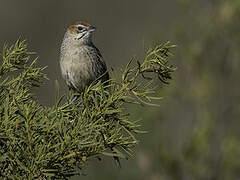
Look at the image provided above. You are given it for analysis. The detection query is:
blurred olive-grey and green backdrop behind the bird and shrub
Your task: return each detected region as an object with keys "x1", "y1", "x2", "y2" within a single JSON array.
[{"x1": 0, "y1": 0, "x2": 240, "y2": 180}]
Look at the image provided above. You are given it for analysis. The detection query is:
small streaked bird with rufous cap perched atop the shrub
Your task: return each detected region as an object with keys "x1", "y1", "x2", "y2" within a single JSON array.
[{"x1": 60, "y1": 21, "x2": 109, "y2": 98}]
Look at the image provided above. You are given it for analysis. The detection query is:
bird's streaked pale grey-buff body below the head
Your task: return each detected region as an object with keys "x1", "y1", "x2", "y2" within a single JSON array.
[{"x1": 60, "y1": 45, "x2": 109, "y2": 92}]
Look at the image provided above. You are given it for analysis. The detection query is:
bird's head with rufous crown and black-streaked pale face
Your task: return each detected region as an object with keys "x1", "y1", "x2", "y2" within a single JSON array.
[{"x1": 67, "y1": 21, "x2": 96, "y2": 45}]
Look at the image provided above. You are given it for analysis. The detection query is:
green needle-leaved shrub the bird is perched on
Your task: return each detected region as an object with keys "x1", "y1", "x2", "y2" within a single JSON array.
[{"x1": 0, "y1": 40, "x2": 175, "y2": 179}]
